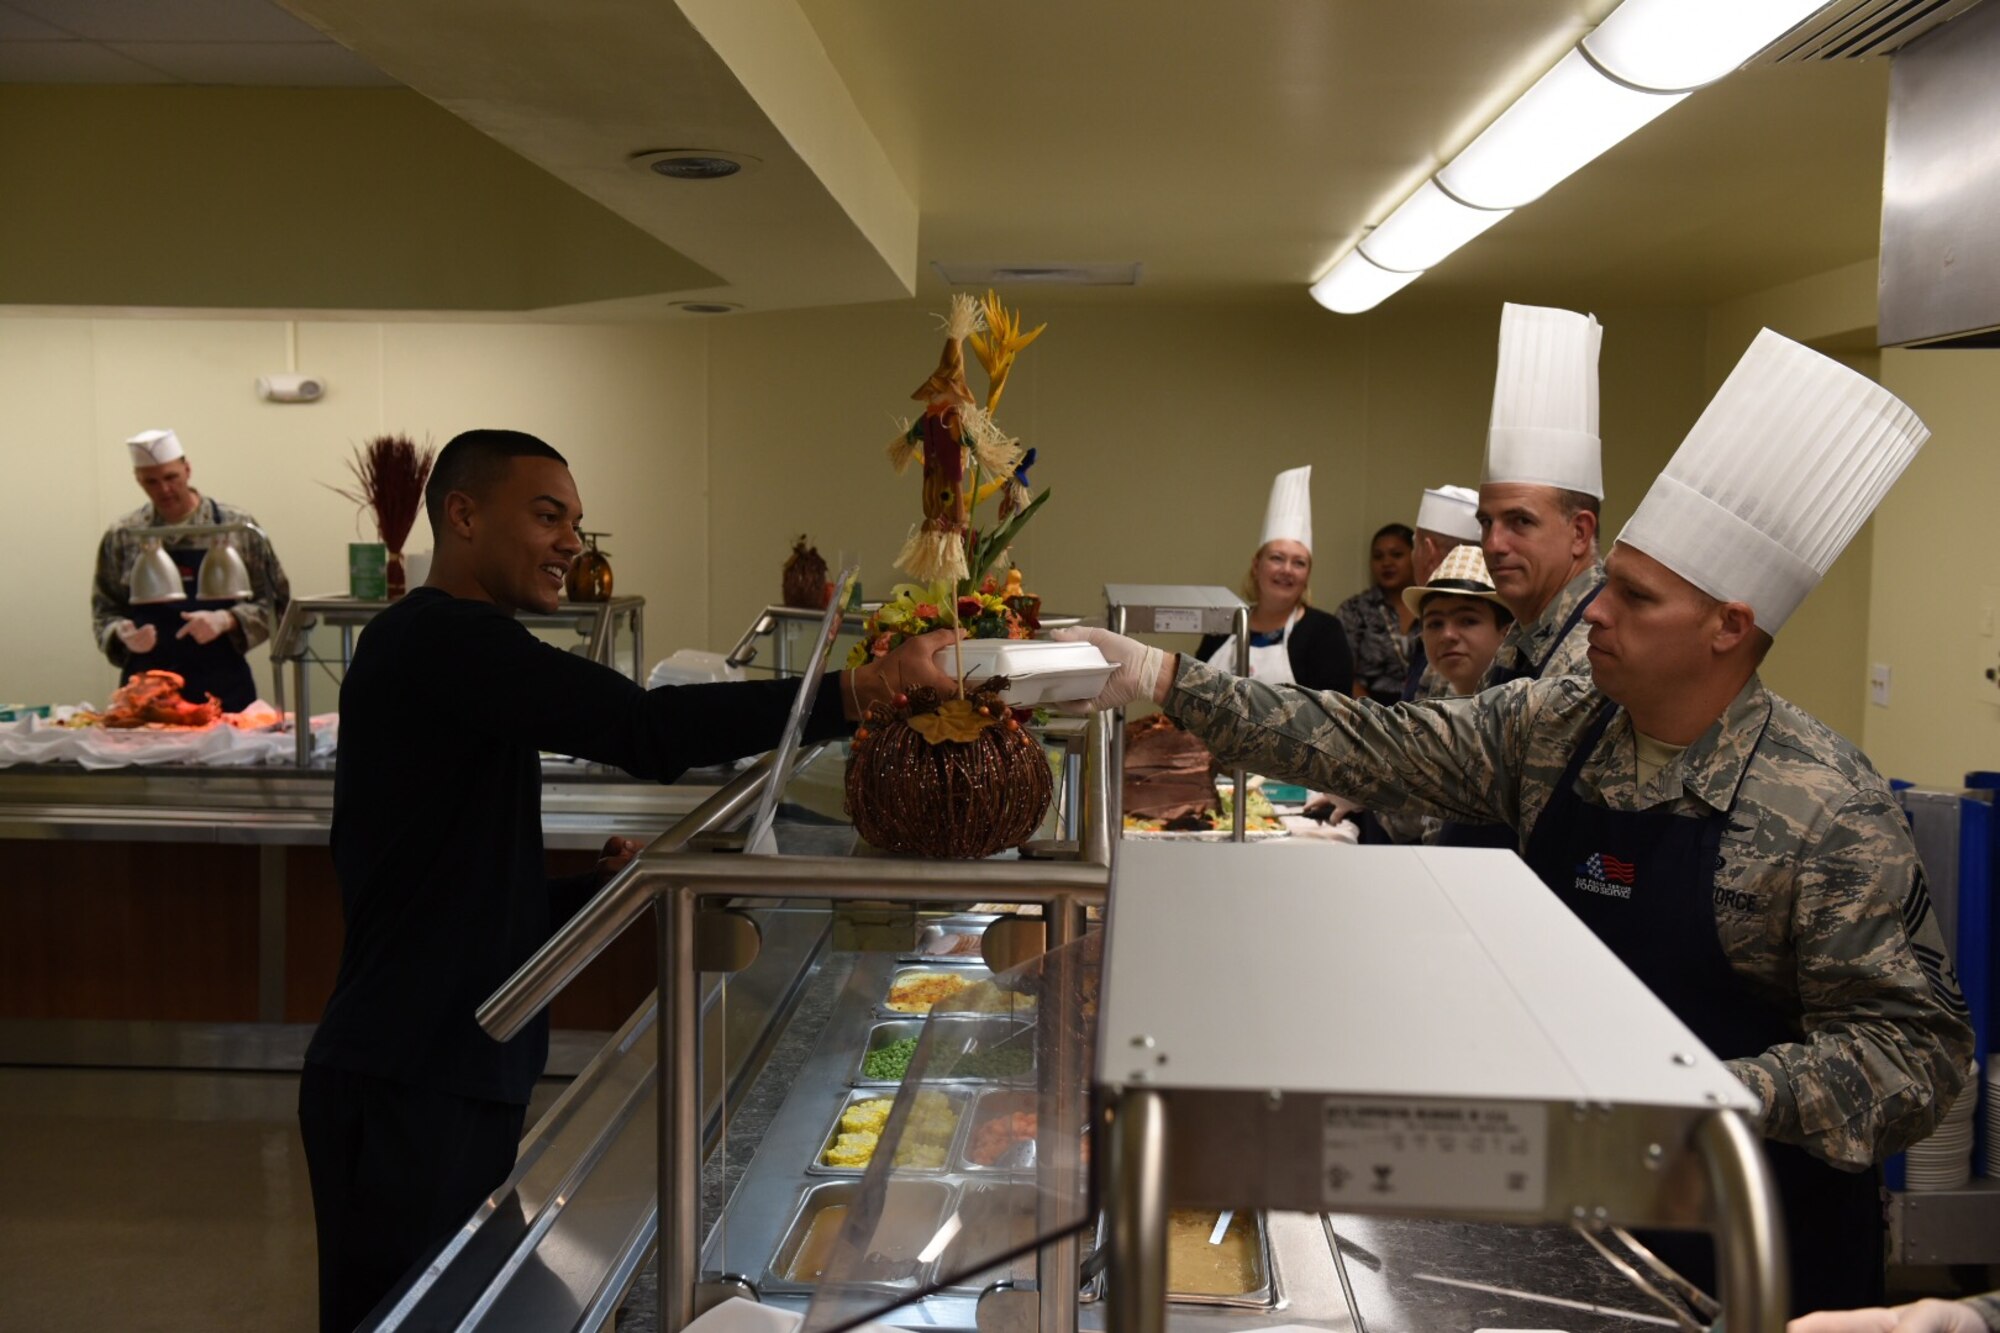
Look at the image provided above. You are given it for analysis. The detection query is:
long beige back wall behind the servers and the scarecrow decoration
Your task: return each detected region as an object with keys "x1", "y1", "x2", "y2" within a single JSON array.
[{"x1": 0, "y1": 302, "x2": 1704, "y2": 701}]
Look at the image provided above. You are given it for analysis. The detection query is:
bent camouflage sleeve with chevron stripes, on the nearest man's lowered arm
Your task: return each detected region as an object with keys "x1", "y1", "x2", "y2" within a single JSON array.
[{"x1": 1730, "y1": 789, "x2": 1972, "y2": 1171}]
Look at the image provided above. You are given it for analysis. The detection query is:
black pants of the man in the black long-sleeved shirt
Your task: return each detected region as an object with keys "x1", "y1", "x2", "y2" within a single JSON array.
[{"x1": 298, "y1": 1063, "x2": 528, "y2": 1333}]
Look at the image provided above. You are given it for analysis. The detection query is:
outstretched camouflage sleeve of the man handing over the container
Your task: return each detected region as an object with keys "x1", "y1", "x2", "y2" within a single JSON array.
[{"x1": 1166, "y1": 656, "x2": 1532, "y2": 825}]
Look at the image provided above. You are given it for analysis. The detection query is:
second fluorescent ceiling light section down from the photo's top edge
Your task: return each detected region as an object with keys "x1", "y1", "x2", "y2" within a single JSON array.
[{"x1": 1438, "y1": 50, "x2": 1686, "y2": 208}]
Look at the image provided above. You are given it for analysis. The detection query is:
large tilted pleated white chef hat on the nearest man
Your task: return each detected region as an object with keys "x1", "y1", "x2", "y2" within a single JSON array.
[{"x1": 1618, "y1": 328, "x2": 1930, "y2": 634}]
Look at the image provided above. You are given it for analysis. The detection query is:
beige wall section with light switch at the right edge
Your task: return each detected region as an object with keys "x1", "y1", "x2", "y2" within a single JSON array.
[{"x1": 1864, "y1": 348, "x2": 2000, "y2": 787}]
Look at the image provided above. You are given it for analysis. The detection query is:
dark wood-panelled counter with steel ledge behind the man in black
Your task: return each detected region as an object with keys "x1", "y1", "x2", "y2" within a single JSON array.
[{"x1": 0, "y1": 763, "x2": 730, "y2": 1040}]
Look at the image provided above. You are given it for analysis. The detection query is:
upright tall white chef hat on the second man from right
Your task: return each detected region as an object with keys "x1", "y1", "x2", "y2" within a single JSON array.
[{"x1": 1480, "y1": 302, "x2": 1604, "y2": 500}]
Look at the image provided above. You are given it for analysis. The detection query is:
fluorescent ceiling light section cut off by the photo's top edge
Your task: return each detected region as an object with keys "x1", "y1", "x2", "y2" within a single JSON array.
[{"x1": 1584, "y1": 0, "x2": 1826, "y2": 92}]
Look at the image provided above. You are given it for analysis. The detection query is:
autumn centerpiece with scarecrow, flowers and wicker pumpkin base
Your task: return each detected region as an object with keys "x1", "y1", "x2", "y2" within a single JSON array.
[{"x1": 846, "y1": 292, "x2": 1054, "y2": 859}]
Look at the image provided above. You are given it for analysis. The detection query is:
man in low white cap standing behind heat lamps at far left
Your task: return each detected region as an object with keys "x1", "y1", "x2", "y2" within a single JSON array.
[{"x1": 90, "y1": 430, "x2": 292, "y2": 713}]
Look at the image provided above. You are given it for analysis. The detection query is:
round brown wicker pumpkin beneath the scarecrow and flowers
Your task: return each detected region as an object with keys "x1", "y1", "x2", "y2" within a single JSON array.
[{"x1": 846, "y1": 681, "x2": 1056, "y2": 861}]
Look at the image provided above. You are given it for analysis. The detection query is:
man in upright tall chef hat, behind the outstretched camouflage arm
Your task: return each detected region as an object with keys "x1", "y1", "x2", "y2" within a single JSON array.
[{"x1": 1478, "y1": 304, "x2": 1604, "y2": 685}]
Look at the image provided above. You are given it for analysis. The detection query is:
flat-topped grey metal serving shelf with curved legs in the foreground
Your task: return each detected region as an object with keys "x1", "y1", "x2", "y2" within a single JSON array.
[{"x1": 1096, "y1": 843, "x2": 1788, "y2": 1333}]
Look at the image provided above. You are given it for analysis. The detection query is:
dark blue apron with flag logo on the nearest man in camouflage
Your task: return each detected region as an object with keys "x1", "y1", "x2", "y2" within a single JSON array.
[{"x1": 1526, "y1": 707, "x2": 1884, "y2": 1315}]
